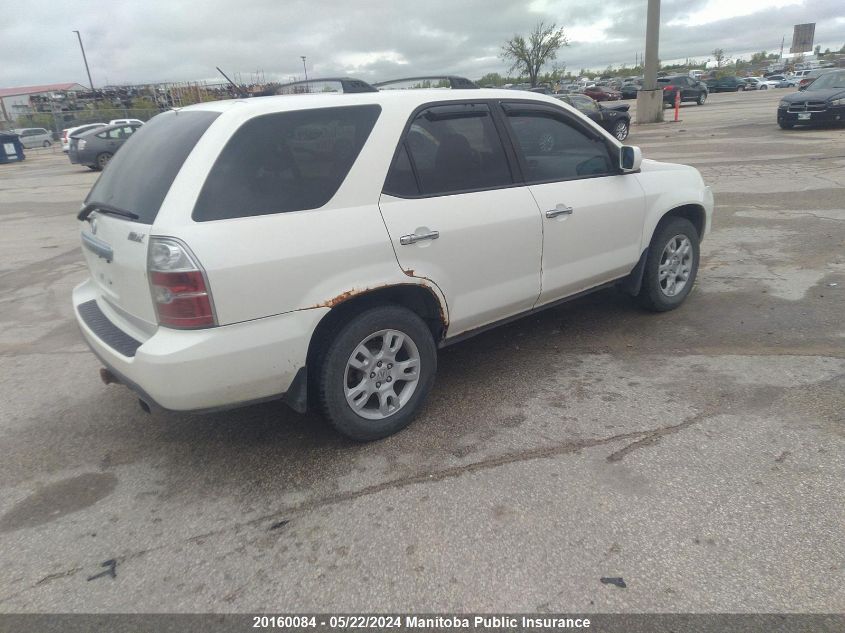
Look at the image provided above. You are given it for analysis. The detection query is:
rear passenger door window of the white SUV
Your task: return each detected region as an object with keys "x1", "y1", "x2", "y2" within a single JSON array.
[{"x1": 385, "y1": 103, "x2": 513, "y2": 195}]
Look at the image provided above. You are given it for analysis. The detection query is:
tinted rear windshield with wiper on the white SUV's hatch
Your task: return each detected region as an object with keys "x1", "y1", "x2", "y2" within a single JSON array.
[{"x1": 85, "y1": 111, "x2": 219, "y2": 224}]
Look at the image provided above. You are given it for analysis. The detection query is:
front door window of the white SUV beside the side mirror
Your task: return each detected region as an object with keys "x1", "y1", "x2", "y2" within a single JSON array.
[{"x1": 507, "y1": 108, "x2": 614, "y2": 183}]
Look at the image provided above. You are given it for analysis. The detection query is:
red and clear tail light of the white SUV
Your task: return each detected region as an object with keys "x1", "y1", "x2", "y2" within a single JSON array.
[{"x1": 147, "y1": 237, "x2": 217, "y2": 329}]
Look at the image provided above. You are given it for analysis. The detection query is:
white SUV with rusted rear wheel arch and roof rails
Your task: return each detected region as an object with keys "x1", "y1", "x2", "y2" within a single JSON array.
[{"x1": 73, "y1": 90, "x2": 713, "y2": 440}]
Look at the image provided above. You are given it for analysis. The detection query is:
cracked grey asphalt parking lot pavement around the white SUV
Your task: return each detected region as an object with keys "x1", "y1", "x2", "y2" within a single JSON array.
[{"x1": 0, "y1": 90, "x2": 845, "y2": 612}]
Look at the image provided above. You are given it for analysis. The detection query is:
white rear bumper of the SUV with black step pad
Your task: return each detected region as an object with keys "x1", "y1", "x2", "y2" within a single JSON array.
[{"x1": 73, "y1": 280, "x2": 328, "y2": 411}]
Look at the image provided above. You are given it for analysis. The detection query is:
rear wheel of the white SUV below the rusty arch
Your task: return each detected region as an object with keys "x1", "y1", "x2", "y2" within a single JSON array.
[{"x1": 319, "y1": 305, "x2": 437, "y2": 442}]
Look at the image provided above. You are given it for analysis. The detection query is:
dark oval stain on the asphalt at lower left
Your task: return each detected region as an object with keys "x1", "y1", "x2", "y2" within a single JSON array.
[{"x1": 0, "y1": 473, "x2": 117, "y2": 533}]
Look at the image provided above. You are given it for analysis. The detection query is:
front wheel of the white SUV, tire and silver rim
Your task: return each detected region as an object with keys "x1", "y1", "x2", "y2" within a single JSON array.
[{"x1": 637, "y1": 217, "x2": 700, "y2": 312}]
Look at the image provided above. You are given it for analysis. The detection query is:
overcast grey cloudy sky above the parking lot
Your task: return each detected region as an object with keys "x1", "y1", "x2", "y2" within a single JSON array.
[{"x1": 0, "y1": 0, "x2": 845, "y2": 87}]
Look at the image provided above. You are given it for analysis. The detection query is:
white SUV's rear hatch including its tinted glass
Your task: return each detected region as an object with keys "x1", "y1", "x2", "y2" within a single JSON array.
[{"x1": 78, "y1": 111, "x2": 219, "y2": 340}]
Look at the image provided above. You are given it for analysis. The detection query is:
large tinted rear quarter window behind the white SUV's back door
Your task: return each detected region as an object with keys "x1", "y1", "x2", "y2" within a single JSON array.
[{"x1": 193, "y1": 105, "x2": 381, "y2": 222}]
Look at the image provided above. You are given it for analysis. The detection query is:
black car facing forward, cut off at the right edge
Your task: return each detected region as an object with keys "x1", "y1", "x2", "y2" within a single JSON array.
[{"x1": 777, "y1": 70, "x2": 845, "y2": 130}]
